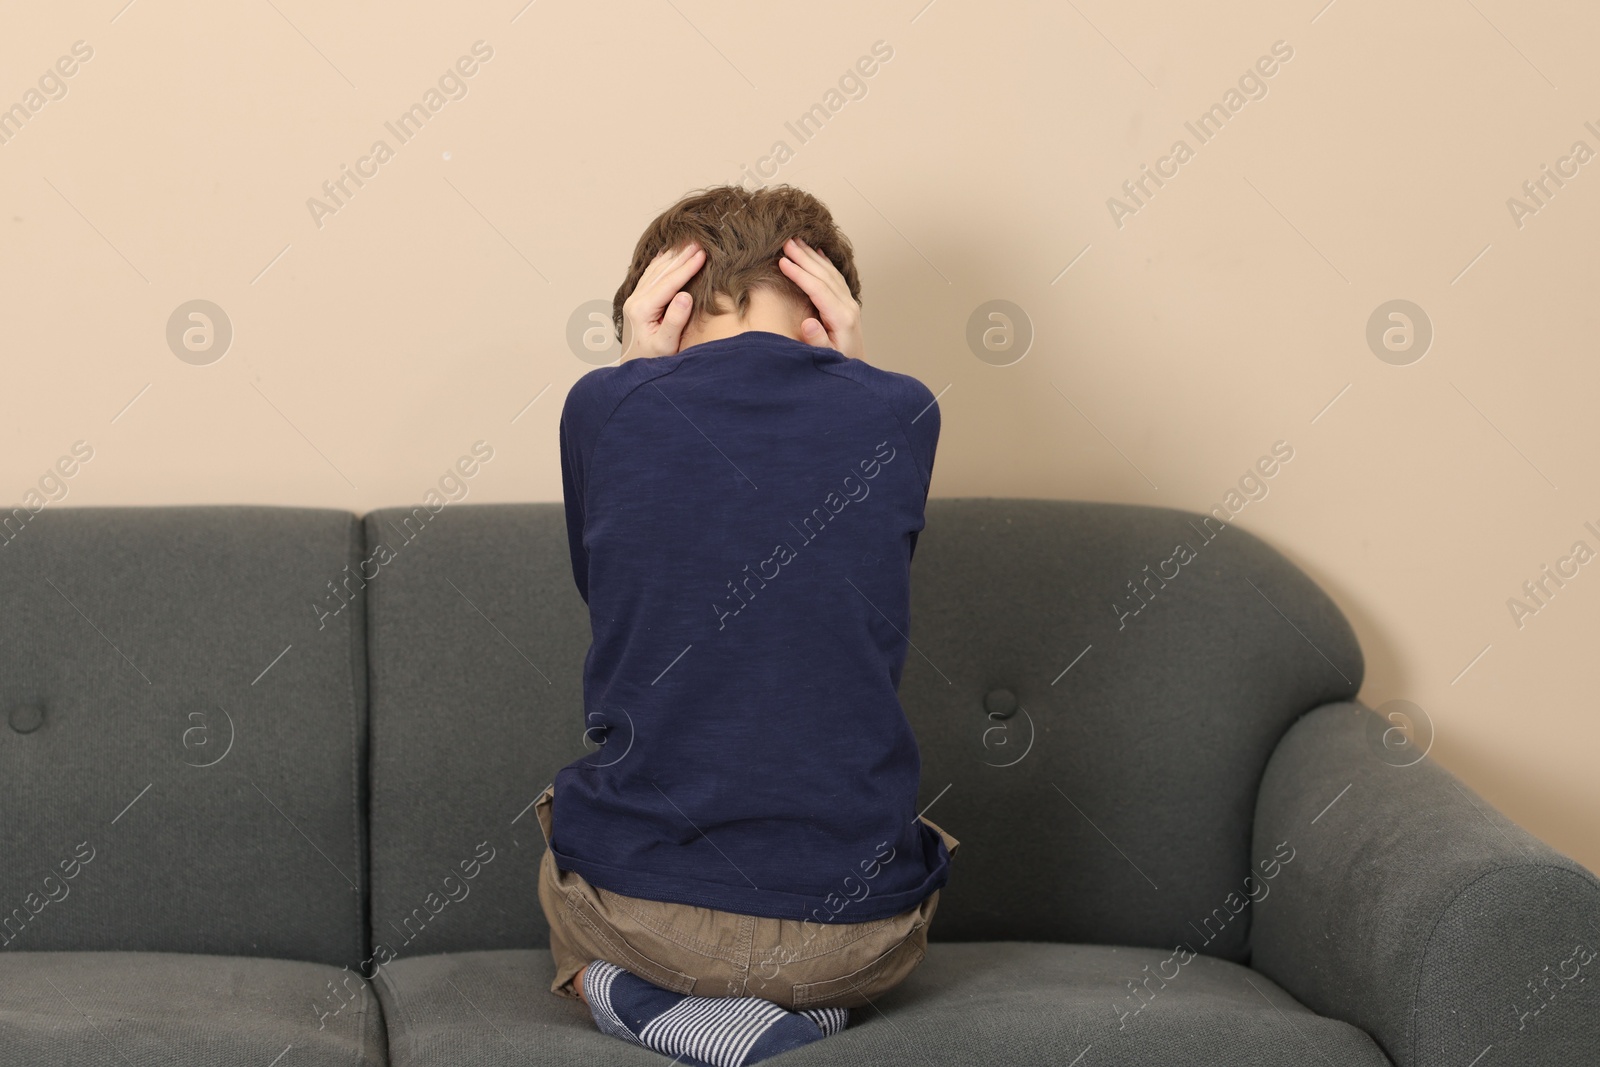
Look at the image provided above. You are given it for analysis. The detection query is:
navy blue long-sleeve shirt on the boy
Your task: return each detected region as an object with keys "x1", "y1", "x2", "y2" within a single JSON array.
[{"x1": 550, "y1": 331, "x2": 949, "y2": 923}]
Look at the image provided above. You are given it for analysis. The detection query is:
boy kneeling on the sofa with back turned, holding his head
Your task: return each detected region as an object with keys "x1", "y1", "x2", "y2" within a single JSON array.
[{"x1": 534, "y1": 186, "x2": 958, "y2": 1067}]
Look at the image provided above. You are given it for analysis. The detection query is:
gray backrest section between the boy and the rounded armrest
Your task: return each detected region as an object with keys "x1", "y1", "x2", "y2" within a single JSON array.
[{"x1": 901, "y1": 499, "x2": 1362, "y2": 961}]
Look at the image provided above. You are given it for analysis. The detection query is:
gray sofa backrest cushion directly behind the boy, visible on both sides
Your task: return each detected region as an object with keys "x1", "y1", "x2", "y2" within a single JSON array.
[{"x1": 366, "y1": 499, "x2": 1362, "y2": 960}]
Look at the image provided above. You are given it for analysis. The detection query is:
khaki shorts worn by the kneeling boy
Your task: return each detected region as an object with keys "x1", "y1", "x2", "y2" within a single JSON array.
[{"x1": 534, "y1": 785, "x2": 960, "y2": 1011}]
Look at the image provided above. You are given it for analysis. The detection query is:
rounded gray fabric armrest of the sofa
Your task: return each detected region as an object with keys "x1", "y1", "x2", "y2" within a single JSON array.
[{"x1": 1251, "y1": 702, "x2": 1600, "y2": 1067}]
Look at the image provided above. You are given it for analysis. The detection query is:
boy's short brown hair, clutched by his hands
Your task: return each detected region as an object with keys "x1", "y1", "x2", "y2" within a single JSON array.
[{"x1": 611, "y1": 186, "x2": 861, "y2": 339}]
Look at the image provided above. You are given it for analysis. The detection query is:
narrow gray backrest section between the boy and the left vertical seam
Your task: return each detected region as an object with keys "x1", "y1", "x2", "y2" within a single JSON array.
[{"x1": 363, "y1": 504, "x2": 589, "y2": 974}]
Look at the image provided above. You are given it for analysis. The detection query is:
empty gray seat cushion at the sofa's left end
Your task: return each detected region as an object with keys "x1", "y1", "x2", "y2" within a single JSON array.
[{"x1": 0, "y1": 952, "x2": 386, "y2": 1067}]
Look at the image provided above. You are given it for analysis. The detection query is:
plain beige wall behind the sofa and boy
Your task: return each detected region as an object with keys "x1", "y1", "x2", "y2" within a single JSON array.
[{"x1": 0, "y1": 0, "x2": 1600, "y2": 869}]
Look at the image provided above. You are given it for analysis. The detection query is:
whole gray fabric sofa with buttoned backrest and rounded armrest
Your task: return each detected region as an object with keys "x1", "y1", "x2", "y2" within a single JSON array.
[{"x1": 0, "y1": 499, "x2": 1600, "y2": 1067}]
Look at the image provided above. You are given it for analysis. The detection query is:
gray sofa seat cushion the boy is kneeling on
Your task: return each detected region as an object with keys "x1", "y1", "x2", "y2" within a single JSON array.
[{"x1": 374, "y1": 941, "x2": 1389, "y2": 1067}]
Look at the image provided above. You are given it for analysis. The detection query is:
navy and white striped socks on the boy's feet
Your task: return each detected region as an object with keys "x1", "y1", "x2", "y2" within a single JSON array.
[{"x1": 584, "y1": 960, "x2": 850, "y2": 1067}]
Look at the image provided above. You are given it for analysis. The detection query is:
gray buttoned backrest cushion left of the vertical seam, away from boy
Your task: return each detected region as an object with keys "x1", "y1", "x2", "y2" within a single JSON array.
[{"x1": 0, "y1": 507, "x2": 366, "y2": 966}]
